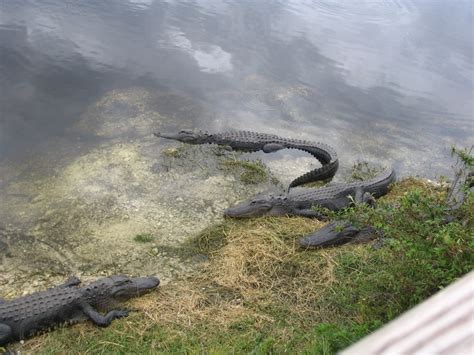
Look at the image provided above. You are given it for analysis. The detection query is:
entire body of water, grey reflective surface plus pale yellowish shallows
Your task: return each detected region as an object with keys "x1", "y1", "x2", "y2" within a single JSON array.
[{"x1": 0, "y1": 0, "x2": 474, "y2": 293}]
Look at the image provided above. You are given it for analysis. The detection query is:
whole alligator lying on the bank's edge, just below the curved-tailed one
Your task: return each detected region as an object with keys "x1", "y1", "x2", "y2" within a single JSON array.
[{"x1": 224, "y1": 169, "x2": 395, "y2": 219}]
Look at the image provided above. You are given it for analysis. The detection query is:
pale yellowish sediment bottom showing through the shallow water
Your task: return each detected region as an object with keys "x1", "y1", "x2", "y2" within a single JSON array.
[{"x1": 0, "y1": 87, "x2": 282, "y2": 297}]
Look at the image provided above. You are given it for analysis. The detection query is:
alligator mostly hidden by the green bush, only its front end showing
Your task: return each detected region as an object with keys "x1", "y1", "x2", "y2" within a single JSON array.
[{"x1": 299, "y1": 221, "x2": 377, "y2": 249}]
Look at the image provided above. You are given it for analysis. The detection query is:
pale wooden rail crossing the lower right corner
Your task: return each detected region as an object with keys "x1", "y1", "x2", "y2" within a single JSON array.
[{"x1": 341, "y1": 272, "x2": 474, "y2": 355}]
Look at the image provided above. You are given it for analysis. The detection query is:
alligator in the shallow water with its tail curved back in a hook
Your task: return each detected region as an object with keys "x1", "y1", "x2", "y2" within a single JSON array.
[{"x1": 154, "y1": 130, "x2": 339, "y2": 189}]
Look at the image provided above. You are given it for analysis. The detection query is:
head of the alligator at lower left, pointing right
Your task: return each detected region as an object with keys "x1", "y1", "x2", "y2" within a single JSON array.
[{"x1": 84, "y1": 275, "x2": 160, "y2": 303}]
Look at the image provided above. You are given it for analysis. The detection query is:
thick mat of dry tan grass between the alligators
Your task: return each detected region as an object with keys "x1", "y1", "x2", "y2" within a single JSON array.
[{"x1": 133, "y1": 218, "x2": 337, "y2": 327}]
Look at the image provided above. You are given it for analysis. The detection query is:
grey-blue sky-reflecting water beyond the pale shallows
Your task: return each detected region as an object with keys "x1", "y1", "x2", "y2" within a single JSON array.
[{"x1": 0, "y1": 0, "x2": 473, "y2": 171}]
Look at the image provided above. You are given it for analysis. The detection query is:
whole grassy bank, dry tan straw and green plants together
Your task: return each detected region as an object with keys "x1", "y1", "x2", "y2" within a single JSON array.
[{"x1": 9, "y1": 179, "x2": 474, "y2": 354}]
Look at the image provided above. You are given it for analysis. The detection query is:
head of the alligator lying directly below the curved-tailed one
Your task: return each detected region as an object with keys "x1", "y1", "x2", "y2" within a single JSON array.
[{"x1": 224, "y1": 194, "x2": 291, "y2": 218}]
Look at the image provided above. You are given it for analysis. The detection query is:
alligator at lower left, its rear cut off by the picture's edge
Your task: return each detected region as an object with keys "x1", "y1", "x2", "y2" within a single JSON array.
[{"x1": 0, "y1": 275, "x2": 160, "y2": 346}]
